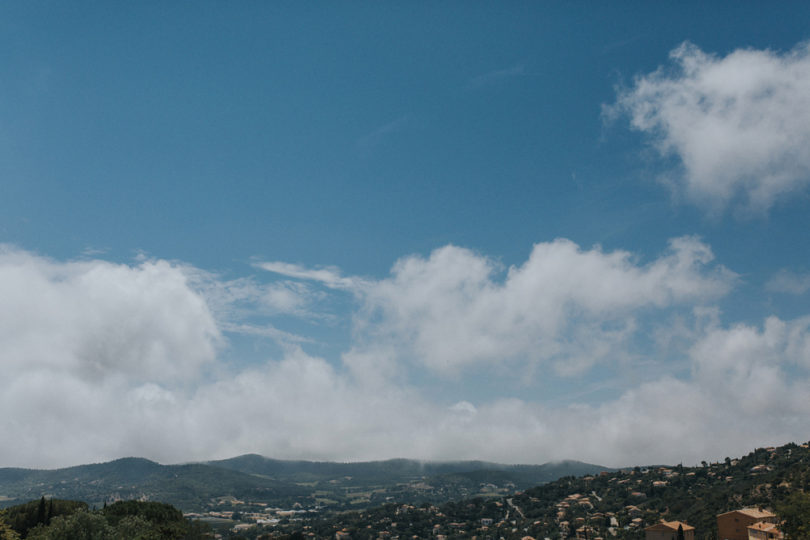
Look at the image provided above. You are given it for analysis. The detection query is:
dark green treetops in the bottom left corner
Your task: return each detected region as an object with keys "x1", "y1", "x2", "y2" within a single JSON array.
[{"x1": 0, "y1": 497, "x2": 211, "y2": 540}]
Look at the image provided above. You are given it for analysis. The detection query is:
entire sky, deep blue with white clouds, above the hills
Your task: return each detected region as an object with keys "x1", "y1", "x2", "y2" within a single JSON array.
[{"x1": 0, "y1": 2, "x2": 810, "y2": 466}]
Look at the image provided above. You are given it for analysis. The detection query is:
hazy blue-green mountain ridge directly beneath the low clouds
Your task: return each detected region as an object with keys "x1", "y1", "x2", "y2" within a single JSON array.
[{"x1": 0, "y1": 454, "x2": 608, "y2": 511}]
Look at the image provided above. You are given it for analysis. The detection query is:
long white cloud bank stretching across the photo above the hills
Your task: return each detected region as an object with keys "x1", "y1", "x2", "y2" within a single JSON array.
[{"x1": 0, "y1": 237, "x2": 810, "y2": 467}]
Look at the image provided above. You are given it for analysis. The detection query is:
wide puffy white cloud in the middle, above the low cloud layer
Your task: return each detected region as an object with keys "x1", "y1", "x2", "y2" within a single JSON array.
[{"x1": 357, "y1": 237, "x2": 735, "y2": 373}]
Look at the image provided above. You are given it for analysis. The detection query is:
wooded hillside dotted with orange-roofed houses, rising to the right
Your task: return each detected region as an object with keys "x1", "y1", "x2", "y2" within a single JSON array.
[{"x1": 204, "y1": 444, "x2": 810, "y2": 540}]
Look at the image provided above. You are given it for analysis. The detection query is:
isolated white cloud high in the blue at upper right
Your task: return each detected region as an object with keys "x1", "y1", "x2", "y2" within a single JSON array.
[{"x1": 606, "y1": 43, "x2": 810, "y2": 212}]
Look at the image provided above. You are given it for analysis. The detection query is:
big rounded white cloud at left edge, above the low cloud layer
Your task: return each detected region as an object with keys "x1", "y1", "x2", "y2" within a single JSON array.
[{"x1": 0, "y1": 247, "x2": 220, "y2": 381}]
